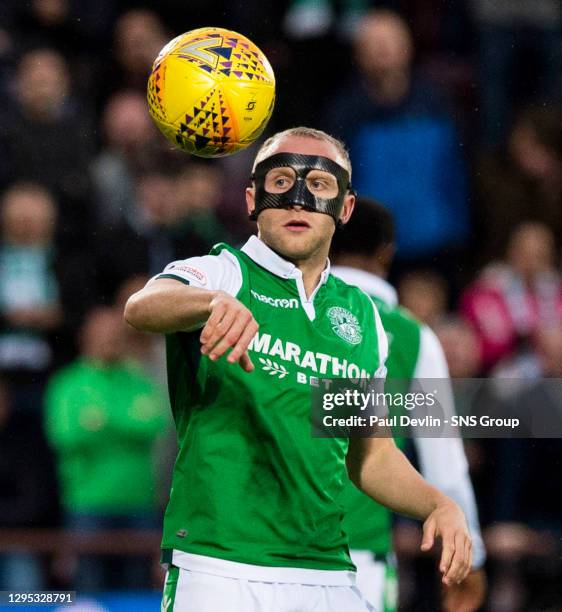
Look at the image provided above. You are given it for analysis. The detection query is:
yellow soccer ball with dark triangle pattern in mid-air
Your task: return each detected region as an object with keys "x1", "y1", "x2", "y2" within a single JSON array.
[{"x1": 147, "y1": 28, "x2": 275, "y2": 157}]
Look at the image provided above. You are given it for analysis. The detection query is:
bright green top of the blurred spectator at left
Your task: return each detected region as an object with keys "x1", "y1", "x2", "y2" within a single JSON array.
[{"x1": 46, "y1": 359, "x2": 167, "y2": 513}]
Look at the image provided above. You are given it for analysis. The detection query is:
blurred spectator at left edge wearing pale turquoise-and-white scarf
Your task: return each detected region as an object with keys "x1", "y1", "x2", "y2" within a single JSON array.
[{"x1": 0, "y1": 183, "x2": 93, "y2": 404}]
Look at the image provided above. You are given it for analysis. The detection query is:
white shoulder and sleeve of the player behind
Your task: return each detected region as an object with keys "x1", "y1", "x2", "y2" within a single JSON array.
[{"x1": 332, "y1": 266, "x2": 486, "y2": 569}]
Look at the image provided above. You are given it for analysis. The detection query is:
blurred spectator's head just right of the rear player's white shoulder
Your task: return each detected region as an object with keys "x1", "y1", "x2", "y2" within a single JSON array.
[{"x1": 398, "y1": 270, "x2": 448, "y2": 327}]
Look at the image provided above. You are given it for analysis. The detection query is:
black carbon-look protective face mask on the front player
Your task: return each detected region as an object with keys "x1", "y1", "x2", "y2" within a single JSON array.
[{"x1": 250, "y1": 153, "x2": 353, "y2": 224}]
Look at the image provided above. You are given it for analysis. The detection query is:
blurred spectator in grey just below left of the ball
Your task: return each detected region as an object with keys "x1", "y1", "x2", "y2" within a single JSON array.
[{"x1": 91, "y1": 90, "x2": 158, "y2": 225}]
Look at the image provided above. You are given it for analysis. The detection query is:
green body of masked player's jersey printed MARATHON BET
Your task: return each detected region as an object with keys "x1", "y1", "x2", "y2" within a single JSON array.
[{"x1": 162, "y1": 245, "x2": 380, "y2": 570}]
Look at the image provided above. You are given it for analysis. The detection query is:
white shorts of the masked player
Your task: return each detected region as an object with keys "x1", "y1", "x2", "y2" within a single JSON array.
[{"x1": 166, "y1": 568, "x2": 374, "y2": 612}]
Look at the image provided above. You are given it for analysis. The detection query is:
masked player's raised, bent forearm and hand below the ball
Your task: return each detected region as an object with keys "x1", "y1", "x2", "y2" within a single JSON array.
[{"x1": 125, "y1": 278, "x2": 258, "y2": 372}]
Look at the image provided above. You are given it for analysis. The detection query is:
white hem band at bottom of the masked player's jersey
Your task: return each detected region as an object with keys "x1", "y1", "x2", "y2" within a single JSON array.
[{"x1": 172, "y1": 550, "x2": 355, "y2": 586}]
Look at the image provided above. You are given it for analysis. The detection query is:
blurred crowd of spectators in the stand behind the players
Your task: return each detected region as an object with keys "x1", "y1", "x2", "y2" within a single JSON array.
[{"x1": 0, "y1": 0, "x2": 562, "y2": 612}]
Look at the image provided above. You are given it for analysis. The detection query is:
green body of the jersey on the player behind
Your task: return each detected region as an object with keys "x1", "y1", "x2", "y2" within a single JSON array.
[{"x1": 336, "y1": 297, "x2": 421, "y2": 555}]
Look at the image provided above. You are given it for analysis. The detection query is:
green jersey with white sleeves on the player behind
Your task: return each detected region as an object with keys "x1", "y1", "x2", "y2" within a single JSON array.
[{"x1": 333, "y1": 266, "x2": 486, "y2": 568}]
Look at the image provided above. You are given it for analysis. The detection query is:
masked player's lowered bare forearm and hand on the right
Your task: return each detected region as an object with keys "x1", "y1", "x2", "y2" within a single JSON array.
[{"x1": 347, "y1": 437, "x2": 472, "y2": 585}]
